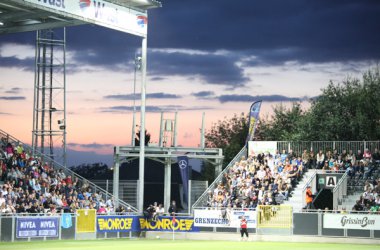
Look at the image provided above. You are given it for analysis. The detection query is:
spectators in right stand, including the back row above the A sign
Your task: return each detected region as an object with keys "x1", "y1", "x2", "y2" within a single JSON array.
[{"x1": 206, "y1": 149, "x2": 380, "y2": 214}]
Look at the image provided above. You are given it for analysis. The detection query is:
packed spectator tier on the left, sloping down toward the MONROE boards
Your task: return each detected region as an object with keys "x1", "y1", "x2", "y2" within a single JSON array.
[{"x1": 0, "y1": 130, "x2": 136, "y2": 214}]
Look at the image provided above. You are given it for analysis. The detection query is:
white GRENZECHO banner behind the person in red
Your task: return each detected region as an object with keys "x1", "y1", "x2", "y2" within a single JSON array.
[{"x1": 194, "y1": 209, "x2": 257, "y2": 228}]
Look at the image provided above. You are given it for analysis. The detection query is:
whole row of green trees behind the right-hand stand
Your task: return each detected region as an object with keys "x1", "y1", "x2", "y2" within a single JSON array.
[{"x1": 257, "y1": 67, "x2": 380, "y2": 141}]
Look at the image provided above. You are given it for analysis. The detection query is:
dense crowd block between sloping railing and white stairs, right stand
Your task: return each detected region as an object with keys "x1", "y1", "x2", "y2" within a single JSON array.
[{"x1": 207, "y1": 152, "x2": 306, "y2": 208}]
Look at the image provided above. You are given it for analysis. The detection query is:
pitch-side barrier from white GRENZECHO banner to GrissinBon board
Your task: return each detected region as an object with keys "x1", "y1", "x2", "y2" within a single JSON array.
[{"x1": 193, "y1": 206, "x2": 380, "y2": 239}]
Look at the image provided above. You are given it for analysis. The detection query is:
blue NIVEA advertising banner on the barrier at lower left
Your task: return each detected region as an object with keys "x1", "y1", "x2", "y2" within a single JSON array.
[{"x1": 16, "y1": 217, "x2": 59, "y2": 238}]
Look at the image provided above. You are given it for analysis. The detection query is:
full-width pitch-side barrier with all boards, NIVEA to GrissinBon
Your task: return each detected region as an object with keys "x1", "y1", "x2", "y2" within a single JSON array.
[{"x1": 0, "y1": 206, "x2": 380, "y2": 242}]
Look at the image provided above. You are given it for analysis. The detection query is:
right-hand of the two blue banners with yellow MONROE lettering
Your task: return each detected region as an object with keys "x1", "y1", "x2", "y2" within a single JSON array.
[{"x1": 139, "y1": 216, "x2": 199, "y2": 232}]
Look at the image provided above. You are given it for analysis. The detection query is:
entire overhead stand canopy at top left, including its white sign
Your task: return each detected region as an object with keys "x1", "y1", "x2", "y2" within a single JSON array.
[{"x1": 0, "y1": 0, "x2": 161, "y2": 37}]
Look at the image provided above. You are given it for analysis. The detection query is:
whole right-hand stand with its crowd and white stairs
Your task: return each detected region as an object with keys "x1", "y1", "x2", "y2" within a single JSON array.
[{"x1": 193, "y1": 147, "x2": 380, "y2": 211}]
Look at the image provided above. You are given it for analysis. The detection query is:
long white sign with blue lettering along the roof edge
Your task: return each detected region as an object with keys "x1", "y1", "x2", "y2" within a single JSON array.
[{"x1": 24, "y1": 0, "x2": 148, "y2": 36}]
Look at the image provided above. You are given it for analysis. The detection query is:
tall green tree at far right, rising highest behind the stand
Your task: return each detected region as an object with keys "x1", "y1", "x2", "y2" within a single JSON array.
[{"x1": 303, "y1": 67, "x2": 380, "y2": 141}]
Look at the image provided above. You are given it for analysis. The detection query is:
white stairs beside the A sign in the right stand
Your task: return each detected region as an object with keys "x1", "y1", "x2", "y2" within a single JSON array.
[{"x1": 283, "y1": 169, "x2": 315, "y2": 212}]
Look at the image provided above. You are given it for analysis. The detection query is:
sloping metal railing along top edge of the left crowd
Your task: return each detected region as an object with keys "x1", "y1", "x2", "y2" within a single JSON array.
[{"x1": 0, "y1": 129, "x2": 138, "y2": 212}]
